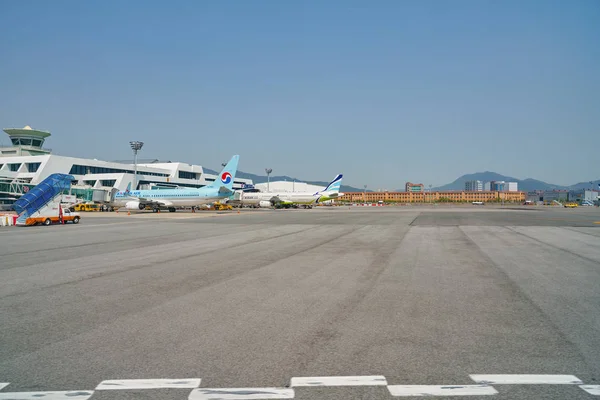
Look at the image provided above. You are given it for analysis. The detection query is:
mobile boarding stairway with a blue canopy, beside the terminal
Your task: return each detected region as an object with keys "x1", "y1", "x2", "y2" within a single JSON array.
[{"x1": 13, "y1": 174, "x2": 75, "y2": 225}]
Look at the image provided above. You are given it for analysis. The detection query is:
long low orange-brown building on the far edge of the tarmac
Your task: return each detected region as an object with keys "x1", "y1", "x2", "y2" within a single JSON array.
[{"x1": 339, "y1": 191, "x2": 526, "y2": 203}]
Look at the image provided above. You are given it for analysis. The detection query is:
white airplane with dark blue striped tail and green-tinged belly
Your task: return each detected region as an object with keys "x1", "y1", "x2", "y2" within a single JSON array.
[{"x1": 236, "y1": 174, "x2": 343, "y2": 208}]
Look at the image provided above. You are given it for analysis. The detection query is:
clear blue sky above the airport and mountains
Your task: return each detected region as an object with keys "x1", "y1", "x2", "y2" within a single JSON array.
[{"x1": 0, "y1": 0, "x2": 600, "y2": 189}]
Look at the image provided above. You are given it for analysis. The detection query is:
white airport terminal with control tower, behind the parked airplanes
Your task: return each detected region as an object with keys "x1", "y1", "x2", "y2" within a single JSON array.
[{"x1": 0, "y1": 126, "x2": 252, "y2": 208}]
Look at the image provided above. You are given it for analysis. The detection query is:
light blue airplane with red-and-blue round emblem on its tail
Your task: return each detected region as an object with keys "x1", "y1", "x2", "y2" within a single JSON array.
[{"x1": 114, "y1": 155, "x2": 240, "y2": 212}]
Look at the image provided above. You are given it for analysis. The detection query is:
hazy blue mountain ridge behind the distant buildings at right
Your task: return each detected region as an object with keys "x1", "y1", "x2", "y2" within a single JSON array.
[{"x1": 433, "y1": 171, "x2": 600, "y2": 192}]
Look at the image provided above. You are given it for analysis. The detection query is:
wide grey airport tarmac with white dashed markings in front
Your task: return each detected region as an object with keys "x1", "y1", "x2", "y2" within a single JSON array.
[{"x1": 0, "y1": 206, "x2": 600, "y2": 400}]
